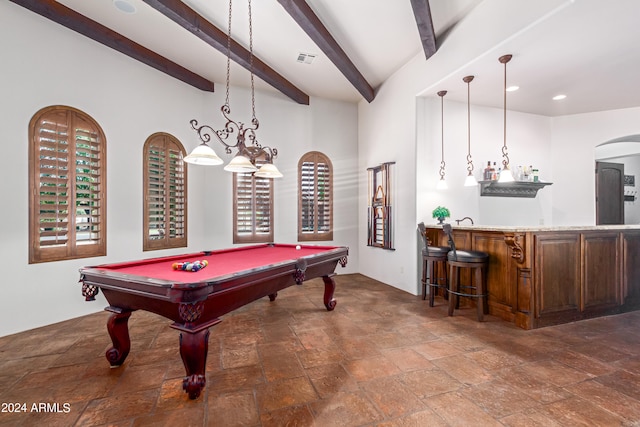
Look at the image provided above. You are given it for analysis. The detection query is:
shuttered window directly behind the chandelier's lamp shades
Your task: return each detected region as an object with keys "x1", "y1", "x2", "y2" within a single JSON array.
[{"x1": 233, "y1": 157, "x2": 273, "y2": 243}]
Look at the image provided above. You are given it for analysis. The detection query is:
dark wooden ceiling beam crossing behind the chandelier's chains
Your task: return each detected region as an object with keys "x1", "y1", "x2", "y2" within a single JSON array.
[{"x1": 143, "y1": 0, "x2": 309, "y2": 105}]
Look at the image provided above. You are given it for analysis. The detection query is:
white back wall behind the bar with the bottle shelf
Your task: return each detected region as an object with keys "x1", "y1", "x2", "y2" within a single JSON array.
[{"x1": 416, "y1": 97, "x2": 553, "y2": 229}]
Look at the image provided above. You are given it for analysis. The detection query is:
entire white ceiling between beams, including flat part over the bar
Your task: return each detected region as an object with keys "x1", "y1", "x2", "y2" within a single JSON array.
[{"x1": 10, "y1": 0, "x2": 640, "y2": 116}]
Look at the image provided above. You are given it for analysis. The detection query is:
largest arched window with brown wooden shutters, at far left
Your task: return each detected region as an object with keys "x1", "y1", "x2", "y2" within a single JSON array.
[{"x1": 29, "y1": 106, "x2": 107, "y2": 263}]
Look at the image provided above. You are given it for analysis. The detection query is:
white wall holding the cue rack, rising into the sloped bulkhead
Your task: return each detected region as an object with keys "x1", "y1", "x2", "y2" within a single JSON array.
[{"x1": 358, "y1": 0, "x2": 566, "y2": 294}]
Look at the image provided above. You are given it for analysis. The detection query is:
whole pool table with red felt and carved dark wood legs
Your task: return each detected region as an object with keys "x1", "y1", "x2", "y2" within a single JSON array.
[{"x1": 80, "y1": 244, "x2": 349, "y2": 399}]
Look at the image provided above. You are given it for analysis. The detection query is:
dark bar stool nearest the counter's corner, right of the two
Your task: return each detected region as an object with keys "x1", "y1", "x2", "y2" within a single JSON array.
[{"x1": 442, "y1": 224, "x2": 489, "y2": 322}]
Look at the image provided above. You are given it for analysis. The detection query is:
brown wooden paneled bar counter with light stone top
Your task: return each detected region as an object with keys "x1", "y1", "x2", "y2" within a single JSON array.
[{"x1": 426, "y1": 225, "x2": 640, "y2": 329}]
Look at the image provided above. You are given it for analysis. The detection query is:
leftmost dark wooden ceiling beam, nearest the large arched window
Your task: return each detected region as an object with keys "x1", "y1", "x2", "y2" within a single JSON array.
[{"x1": 10, "y1": 0, "x2": 214, "y2": 92}]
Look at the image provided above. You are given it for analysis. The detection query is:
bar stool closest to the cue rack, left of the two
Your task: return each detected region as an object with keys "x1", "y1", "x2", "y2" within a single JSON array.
[{"x1": 418, "y1": 222, "x2": 451, "y2": 307}]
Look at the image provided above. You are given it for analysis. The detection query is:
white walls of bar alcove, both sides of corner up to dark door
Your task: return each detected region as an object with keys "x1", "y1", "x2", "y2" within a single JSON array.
[{"x1": 417, "y1": 98, "x2": 640, "y2": 232}]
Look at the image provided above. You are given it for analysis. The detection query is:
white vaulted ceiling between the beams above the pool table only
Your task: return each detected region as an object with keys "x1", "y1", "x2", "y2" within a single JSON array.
[{"x1": 11, "y1": 0, "x2": 479, "y2": 104}]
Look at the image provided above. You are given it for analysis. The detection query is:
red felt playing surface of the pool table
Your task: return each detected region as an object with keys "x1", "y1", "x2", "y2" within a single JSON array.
[{"x1": 93, "y1": 244, "x2": 339, "y2": 283}]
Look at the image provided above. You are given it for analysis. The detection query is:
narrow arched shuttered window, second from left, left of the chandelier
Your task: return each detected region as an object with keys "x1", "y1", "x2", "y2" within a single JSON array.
[{"x1": 143, "y1": 132, "x2": 187, "y2": 251}]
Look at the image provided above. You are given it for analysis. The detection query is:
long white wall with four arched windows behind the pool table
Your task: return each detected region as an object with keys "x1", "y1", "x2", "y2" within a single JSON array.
[{"x1": 0, "y1": 2, "x2": 358, "y2": 336}]
